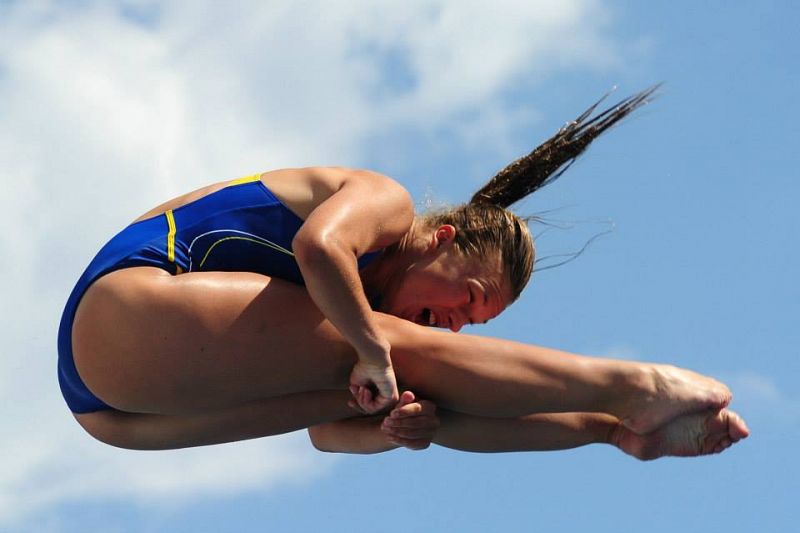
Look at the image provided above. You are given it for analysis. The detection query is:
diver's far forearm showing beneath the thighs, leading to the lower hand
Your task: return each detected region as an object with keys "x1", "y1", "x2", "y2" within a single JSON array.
[{"x1": 308, "y1": 415, "x2": 398, "y2": 454}]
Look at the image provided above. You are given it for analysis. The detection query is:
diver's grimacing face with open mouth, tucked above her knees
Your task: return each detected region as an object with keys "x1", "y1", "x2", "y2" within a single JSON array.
[{"x1": 382, "y1": 246, "x2": 511, "y2": 331}]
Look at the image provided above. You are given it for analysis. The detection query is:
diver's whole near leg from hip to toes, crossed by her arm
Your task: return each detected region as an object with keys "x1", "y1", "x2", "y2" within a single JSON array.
[{"x1": 73, "y1": 267, "x2": 730, "y2": 432}]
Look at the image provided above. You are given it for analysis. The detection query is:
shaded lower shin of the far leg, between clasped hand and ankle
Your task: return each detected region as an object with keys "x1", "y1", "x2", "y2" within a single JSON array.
[{"x1": 433, "y1": 410, "x2": 619, "y2": 453}]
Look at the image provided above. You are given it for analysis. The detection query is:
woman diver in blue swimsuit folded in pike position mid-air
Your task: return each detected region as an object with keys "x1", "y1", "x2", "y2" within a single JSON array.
[{"x1": 58, "y1": 89, "x2": 747, "y2": 458}]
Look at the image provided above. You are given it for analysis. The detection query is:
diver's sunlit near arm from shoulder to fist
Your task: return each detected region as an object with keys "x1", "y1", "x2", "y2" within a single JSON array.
[{"x1": 292, "y1": 171, "x2": 414, "y2": 412}]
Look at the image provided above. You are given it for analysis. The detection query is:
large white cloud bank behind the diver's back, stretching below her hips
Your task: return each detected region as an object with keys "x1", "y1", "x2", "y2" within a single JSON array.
[{"x1": 0, "y1": 0, "x2": 616, "y2": 523}]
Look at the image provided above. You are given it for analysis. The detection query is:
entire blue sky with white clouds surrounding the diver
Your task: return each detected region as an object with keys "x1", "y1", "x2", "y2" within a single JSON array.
[{"x1": 0, "y1": 0, "x2": 800, "y2": 532}]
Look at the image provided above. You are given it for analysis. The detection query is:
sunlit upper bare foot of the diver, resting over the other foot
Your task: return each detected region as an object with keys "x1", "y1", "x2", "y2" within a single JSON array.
[{"x1": 620, "y1": 365, "x2": 732, "y2": 435}]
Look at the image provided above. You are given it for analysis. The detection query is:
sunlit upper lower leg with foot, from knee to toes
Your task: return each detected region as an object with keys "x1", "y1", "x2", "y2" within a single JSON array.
[{"x1": 381, "y1": 315, "x2": 731, "y2": 433}]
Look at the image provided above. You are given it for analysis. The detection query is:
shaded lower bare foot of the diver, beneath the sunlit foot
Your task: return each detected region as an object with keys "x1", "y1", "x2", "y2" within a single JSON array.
[{"x1": 611, "y1": 409, "x2": 750, "y2": 461}]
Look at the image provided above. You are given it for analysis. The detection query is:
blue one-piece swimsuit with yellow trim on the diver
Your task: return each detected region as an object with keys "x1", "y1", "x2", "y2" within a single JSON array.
[{"x1": 58, "y1": 175, "x2": 379, "y2": 413}]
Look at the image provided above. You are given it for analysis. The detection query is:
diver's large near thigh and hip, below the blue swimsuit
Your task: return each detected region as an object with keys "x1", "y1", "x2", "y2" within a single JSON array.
[{"x1": 72, "y1": 267, "x2": 355, "y2": 414}]
